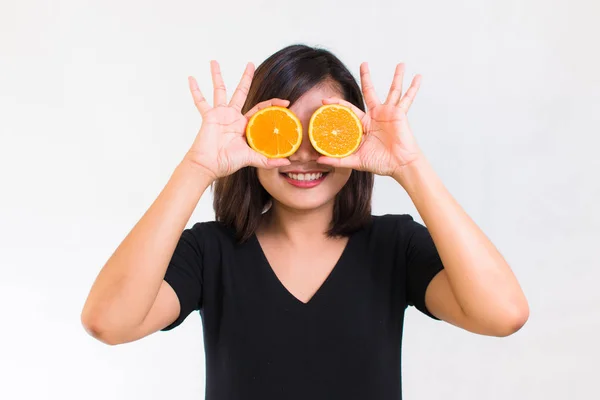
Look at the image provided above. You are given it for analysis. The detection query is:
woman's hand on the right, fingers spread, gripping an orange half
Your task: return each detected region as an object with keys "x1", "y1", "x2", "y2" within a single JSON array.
[{"x1": 317, "y1": 63, "x2": 421, "y2": 176}]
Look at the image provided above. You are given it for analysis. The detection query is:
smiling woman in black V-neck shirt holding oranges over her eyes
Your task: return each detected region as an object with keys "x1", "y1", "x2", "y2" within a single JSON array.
[{"x1": 82, "y1": 45, "x2": 529, "y2": 400}]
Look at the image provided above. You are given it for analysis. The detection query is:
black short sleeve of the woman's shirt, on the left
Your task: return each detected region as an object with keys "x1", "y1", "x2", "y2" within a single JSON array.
[{"x1": 161, "y1": 223, "x2": 203, "y2": 331}]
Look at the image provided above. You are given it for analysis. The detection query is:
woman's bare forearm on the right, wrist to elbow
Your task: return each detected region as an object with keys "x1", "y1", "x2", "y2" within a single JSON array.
[{"x1": 394, "y1": 158, "x2": 527, "y2": 325}]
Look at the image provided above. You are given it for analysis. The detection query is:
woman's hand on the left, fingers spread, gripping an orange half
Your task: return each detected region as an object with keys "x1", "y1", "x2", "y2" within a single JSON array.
[{"x1": 184, "y1": 61, "x2": 290, "y2": 179}]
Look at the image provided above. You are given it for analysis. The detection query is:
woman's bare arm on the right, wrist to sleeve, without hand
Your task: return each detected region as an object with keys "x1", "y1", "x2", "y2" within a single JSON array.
[{"x1": 394, "y1": 157, "x2": 529, "y2": 336}]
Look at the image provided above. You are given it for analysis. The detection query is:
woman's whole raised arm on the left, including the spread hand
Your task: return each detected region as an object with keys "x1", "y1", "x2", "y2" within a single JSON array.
[{"x1": 81, "y1": 61, "x2": 289, "y2": 344}]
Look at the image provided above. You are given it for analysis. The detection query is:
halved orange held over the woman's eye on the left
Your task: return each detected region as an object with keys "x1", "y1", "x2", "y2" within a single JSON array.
[{"x1": 246, "y1": 106, "x2": 302, "y2": 158}]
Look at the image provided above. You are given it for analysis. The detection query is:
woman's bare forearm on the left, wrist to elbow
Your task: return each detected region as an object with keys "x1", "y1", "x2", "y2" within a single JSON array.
[{"x1": 82, "y1": 161, "x2": 212, "y2": 330}]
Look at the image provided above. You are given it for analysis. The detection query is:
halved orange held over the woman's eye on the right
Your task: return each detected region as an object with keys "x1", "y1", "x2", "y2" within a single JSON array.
[{"x1": 308, "y1": 104, "x2": 363, "y2": 158}]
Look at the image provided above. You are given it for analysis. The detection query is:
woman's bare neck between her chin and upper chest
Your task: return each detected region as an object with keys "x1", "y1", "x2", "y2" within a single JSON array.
[{"x1": 264, "y1": 202, "x2": 333, "y2": 242}]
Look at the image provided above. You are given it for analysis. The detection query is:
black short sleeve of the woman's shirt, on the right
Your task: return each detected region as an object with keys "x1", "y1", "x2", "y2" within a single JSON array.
[{"x1": 400, "y1": 217, "x2": 444, "y2": 320}]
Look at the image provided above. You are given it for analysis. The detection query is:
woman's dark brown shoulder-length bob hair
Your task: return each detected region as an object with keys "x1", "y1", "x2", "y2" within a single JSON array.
[{"x1": 213, "y1": 44, "x2": 374, "y2": 242}]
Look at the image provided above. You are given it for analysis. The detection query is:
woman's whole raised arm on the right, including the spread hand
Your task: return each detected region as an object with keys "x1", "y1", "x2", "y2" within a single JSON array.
[{"x1": 319, "y1": 63, "x2": 529, "y2": 336}]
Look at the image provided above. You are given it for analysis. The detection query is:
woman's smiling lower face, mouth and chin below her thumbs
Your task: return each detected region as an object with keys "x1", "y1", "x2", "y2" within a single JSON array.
[{"x1": 258, "y1": 169, "x2": 352, "y2": 211}]
